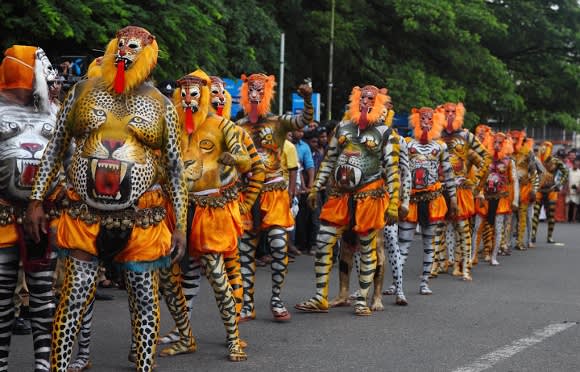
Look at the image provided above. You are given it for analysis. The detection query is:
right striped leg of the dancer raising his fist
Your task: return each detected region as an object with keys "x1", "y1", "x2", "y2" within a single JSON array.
[{"x1": 268, "y1": 227, "x2": 291, "y2": 321}]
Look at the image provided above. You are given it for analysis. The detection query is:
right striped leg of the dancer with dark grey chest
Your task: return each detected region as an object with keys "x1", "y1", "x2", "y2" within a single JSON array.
[{"x1": 354, "y1": 230, "x2": 377, "y2": 316}]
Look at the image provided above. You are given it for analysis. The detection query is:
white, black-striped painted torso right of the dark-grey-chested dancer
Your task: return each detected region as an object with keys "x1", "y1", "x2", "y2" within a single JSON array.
[{"x1": 407, "y1": 139, "x2": 444, "y2": 190}]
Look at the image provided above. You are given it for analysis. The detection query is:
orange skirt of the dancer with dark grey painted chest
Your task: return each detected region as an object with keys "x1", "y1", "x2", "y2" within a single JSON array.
[{"x1": 320, "y1": 180, "x2": 389, "y2": 233}]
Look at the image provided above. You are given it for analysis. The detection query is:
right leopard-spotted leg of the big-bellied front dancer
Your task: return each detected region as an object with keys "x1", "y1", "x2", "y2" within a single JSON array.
[{"x1": 125, "y1": 270, "x2": 160, "y2": 372}]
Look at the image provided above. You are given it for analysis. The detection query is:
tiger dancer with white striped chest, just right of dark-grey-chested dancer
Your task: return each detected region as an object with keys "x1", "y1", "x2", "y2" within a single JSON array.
[{"x1": 399, "y1": 107, "x2": 457, "y2": 295}]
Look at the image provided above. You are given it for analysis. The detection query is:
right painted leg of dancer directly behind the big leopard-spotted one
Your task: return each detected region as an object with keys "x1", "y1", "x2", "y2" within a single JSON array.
[{"x1": 201, "y1": 253, "x2": 248, "y2": 362}]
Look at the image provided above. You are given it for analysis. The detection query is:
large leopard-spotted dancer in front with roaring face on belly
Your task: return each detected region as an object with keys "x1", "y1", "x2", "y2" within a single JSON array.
[{"x1": 27, "y1": 26, "x2": 187, "y2": 371}]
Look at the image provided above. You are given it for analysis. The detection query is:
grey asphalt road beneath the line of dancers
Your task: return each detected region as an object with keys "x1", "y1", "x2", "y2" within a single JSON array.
[{"x1": 10, "y1": 223, "x2": 580, "y2": 372}]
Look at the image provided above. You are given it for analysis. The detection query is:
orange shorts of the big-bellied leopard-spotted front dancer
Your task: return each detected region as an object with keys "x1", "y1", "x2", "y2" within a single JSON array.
[{"x1": 56, "y1": 189, "x2": 171, "y2": 264}]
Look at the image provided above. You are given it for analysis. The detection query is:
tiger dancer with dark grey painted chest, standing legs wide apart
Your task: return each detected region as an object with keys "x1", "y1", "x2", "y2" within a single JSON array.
[{"x1": 295, "y1": 85, "x2": 400, "y2": 316}]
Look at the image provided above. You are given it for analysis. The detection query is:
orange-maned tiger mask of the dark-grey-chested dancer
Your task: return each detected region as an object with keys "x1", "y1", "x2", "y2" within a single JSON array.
[{"x1": 348, "y1": 85, "x2": 390, "y2": 130}]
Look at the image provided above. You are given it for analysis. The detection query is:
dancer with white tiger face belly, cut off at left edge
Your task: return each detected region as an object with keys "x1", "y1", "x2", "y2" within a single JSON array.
[{"x1": 0, "y1": 45, "x2": 58, "y2": 371}]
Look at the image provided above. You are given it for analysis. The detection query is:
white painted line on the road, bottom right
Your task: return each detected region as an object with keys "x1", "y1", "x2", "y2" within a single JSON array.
[{"x1": 453, "y1": 322, "x2": 577, "y2": 372}]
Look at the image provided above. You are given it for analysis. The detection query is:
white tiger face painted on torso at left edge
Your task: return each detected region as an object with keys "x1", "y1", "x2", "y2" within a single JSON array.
[{"x1": 0, "y1": 100, "x2": 56, "y2": 201}]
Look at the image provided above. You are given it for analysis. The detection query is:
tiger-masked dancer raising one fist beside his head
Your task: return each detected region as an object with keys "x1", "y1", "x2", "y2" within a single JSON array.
[{"x1": 237, "y1": 74, "x2": 314, "y2": 321}]
